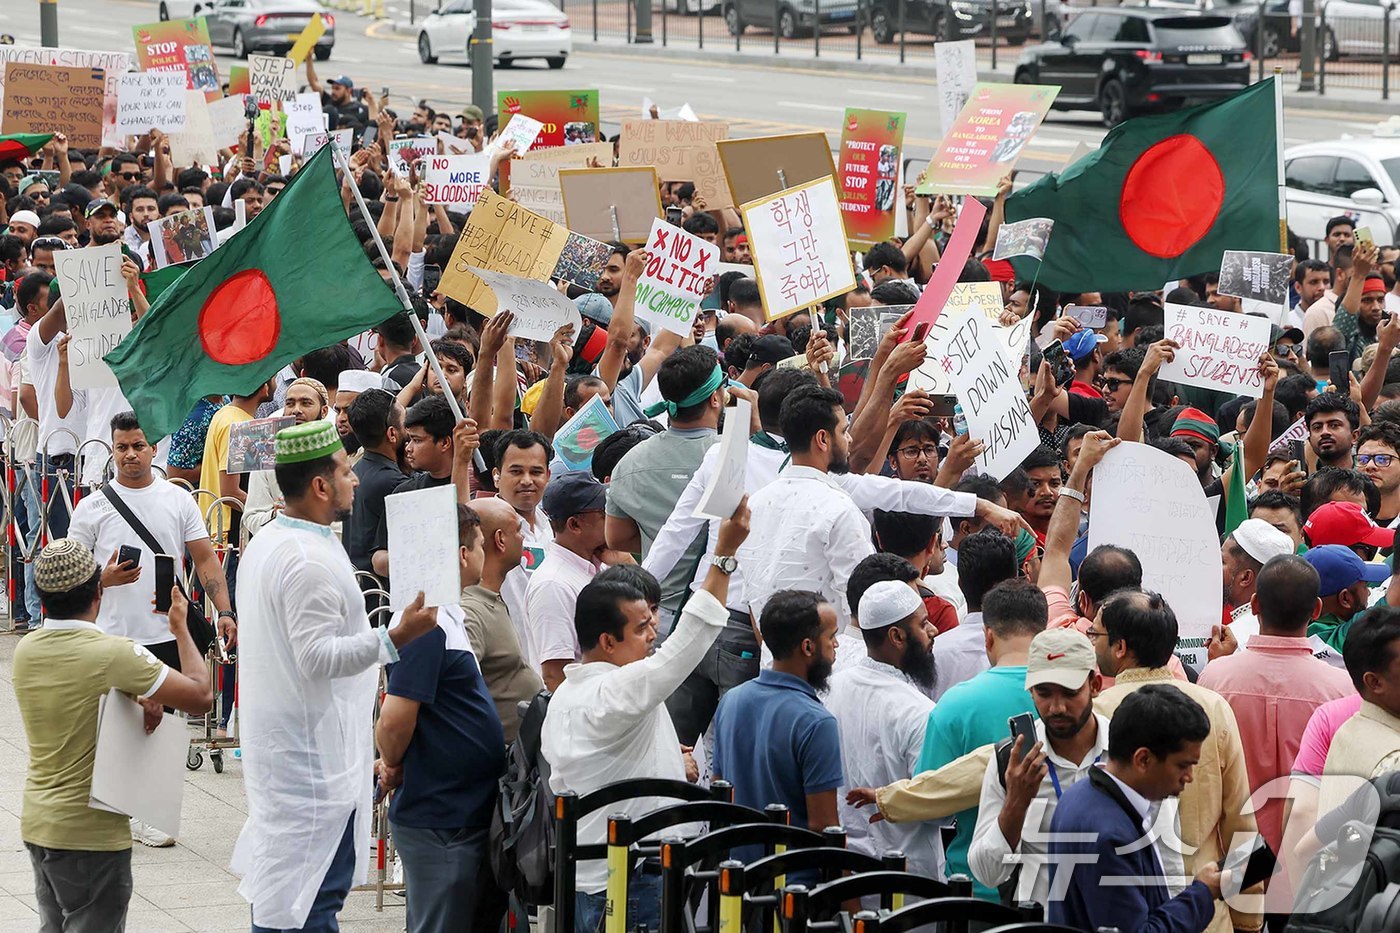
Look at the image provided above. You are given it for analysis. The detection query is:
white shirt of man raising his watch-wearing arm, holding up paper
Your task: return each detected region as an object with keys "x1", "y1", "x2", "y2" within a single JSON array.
[{"x1": 540, "y1": 590, "x2": 729, "y2": 894}]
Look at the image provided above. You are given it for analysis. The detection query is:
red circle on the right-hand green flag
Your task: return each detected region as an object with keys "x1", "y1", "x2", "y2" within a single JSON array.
[{"x1": 1119, "y1": 133, "x2": 1225, "y2": 259}]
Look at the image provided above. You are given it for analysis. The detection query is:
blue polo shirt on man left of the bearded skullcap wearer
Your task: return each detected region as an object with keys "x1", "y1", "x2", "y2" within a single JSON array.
[{"x1": 714, "y1": 671, "x2": 843, "y2": 828}]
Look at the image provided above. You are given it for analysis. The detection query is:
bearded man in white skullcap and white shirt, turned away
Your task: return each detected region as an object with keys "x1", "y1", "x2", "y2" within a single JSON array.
[{"x1": 826, "y1": 577, "x2": 944, "y2": 878}]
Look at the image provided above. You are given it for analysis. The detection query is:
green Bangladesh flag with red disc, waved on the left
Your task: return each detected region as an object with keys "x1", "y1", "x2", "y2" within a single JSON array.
[{"x1": 102, "y1": 146, "x2": 403, "y2": 437}]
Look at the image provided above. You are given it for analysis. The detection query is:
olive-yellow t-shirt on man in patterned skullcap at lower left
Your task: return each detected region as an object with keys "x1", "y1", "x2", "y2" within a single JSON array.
[{"x1": 14, "y1": 619, "x2": 169, "y2": 852}]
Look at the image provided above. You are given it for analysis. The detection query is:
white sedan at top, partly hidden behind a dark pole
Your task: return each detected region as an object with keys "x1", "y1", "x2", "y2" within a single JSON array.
[{"x1": 419, "y1": 0, "x2": 574, "y2": 69}]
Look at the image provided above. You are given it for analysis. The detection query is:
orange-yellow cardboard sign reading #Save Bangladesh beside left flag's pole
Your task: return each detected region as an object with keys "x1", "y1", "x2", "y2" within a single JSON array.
[{"x1": 438, "y1": 188, "x2": 568, "y2": 317}]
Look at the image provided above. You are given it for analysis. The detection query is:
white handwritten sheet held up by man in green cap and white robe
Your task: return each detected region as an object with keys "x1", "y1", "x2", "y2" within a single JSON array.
[{"x1": 384, "y1": 483, "x2": 462, "y2": 612}]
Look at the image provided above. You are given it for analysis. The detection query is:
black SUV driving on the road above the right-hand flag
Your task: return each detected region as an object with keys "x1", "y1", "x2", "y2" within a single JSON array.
[{"x1": 1015, "y1": 7, "x2": 1253, "y2": 126}]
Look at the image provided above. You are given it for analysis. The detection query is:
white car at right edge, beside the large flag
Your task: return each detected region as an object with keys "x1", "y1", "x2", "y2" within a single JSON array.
[{"x1": 1284, "y1": 127, "x2": 1400, "y2": 245}]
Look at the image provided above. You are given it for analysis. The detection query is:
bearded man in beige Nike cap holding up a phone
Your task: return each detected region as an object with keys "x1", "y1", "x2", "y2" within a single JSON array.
[{"x1": 967, "y1": 629, "x2": 1109, "y2": 905}]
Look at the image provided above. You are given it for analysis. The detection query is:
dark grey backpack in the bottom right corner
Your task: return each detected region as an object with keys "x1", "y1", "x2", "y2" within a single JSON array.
[{"x1": 1284, "y1": 772, "x2": 1400, "y2": 933}]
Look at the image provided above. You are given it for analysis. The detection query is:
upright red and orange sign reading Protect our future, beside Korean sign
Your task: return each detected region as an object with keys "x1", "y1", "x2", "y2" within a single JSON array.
[{"x1": 836, "y1": 106, "x2": 906, "y2": 248}]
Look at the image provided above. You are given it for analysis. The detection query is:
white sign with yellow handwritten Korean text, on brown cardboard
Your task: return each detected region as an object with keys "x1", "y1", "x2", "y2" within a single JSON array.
[{"x1": 741, "y1": 177, "x2": 855, "y2": 321}]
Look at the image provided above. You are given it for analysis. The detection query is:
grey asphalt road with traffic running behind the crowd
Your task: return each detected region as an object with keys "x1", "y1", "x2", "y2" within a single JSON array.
[{"x1": 0, "y1": 0, "x2": 1379, "y2": 172}]
